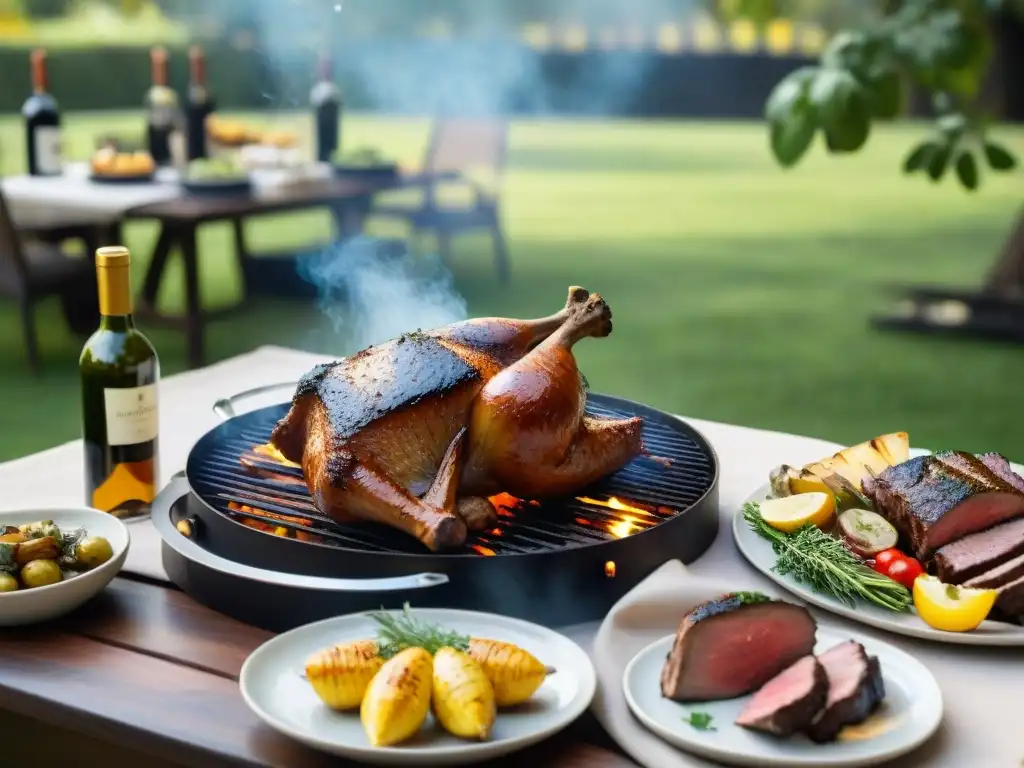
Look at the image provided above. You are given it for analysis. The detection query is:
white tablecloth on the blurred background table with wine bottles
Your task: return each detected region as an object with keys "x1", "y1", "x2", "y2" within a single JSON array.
[{"x1": 0, "y1": 163, "x2": 181, "y2": 221}]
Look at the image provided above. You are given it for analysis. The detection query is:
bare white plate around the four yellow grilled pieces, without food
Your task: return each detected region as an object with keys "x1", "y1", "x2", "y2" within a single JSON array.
[{"x1": 239, "y1": 608, "x2": 596, "y2": 766}]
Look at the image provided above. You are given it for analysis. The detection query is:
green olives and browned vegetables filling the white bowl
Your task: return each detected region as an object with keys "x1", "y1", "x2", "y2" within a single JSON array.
[{"x1": 0, "y1": 520, "x2": 114, "y2": 592}]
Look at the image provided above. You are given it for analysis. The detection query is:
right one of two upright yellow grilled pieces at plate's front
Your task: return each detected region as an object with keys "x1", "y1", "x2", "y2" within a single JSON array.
[{"x1": 431, "y1": 647, "x2": 498, "y2": 741}]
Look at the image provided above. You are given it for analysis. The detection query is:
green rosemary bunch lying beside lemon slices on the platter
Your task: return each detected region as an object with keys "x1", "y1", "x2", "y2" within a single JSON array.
[{"x1": 743, "y1": 502, "x2": 912, "y2": 611}]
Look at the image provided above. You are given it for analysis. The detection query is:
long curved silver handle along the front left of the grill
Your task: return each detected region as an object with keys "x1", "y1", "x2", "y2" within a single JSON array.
[{"x1": 151, "y1": 475, "x2": 449, "y2": 592}]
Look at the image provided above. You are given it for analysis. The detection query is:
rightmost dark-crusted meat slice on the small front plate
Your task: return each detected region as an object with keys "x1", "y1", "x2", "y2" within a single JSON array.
[{"x1": 807, "y1": 640, "x2": 886, "y2": 742}]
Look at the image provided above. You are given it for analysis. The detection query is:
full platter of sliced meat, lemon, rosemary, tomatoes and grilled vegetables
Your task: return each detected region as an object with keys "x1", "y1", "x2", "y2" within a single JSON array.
[{"x1": 733, "y1": 432, "x2": 1024, "y2": 646}]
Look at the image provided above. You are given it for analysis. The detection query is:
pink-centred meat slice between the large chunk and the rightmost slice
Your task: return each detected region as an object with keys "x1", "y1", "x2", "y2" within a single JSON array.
[{"x1": 736, "y1": 655, "x2": 828, "y2": 736}]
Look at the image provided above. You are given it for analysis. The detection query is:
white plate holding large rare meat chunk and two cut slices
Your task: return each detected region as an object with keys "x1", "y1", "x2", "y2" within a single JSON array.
[{"x1": 623, "y1": 592, "x2": 942, "y2": 766}]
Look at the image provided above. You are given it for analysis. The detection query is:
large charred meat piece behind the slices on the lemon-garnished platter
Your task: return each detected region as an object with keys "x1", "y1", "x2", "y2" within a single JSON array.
[{"x1": 864, "y1": 452, "x2": 1024, "y2": 560}]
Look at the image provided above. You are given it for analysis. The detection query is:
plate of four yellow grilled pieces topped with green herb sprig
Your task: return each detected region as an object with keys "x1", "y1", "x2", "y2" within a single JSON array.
[{"x1": 240, "y1": 605, "x2": 595, "y2": 765}]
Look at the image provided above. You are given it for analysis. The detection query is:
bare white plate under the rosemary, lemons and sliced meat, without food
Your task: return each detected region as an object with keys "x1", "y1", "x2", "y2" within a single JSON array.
[{"x1": 732, "y1": 450, "x2": 1024, "y2": 646}]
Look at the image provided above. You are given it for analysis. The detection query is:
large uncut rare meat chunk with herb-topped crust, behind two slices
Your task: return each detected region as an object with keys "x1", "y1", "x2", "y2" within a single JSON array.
[{"x1": 662, "y1": 593, "x2": 817, "y2": 701}]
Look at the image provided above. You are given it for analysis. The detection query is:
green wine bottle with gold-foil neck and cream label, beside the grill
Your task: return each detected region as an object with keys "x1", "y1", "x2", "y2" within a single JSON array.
[{"x1": 79, "y1": 246, "x2": 160, "y2": 518}]
